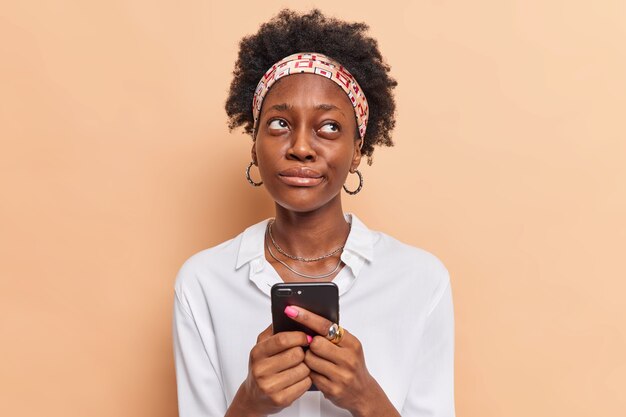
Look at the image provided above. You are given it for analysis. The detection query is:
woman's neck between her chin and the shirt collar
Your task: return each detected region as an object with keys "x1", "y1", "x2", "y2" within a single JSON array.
[{"x1": 272, "y1": 198, "x2": 350, "y2": 257}]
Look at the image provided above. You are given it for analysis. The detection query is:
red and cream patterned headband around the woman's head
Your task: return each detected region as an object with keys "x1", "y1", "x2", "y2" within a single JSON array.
[{"x1": 252, "y1": 52, "x2": 369, "y2": 148}]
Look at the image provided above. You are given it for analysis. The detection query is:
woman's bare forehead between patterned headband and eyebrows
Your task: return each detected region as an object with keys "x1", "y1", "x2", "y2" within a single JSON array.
[{"x1": 263, "y1": 74, "x2": 354, "y2": 112}]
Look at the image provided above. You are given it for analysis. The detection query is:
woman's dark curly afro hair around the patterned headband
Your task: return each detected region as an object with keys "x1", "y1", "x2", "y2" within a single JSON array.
[{"x1": 226, "y1": 9, "x2": 398, "y2": 165}]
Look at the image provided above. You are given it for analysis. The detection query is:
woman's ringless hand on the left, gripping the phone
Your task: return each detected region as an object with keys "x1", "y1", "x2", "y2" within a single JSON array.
[{"x1": 225, "y1": 325, "x2": 312, "y2": 417}]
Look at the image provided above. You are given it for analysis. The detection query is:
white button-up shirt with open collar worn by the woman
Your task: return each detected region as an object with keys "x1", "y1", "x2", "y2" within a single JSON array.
[{"x1": 174, "y1": 215, "x2": 454, "y2": 417}]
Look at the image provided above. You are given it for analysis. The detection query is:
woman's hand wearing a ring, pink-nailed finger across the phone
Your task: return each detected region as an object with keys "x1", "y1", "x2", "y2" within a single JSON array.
[{"x1": 288, "y1": 306, "x2": 399, "y2": 417}]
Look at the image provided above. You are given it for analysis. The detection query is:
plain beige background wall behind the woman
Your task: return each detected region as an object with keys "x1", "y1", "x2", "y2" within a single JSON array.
[{"x1": 0, "y1": 0, "x2": 626, "y2": 417}]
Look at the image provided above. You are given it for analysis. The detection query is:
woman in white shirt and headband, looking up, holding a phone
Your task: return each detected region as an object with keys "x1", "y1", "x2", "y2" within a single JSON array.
[{"x1": 174, "y1": 10, "x2": 454, "y2": 417}]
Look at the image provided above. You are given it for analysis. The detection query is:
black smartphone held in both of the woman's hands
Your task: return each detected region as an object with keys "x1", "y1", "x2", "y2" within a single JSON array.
[{"x1": 271, "y1": 282, "x2": 339, "y2": 391}]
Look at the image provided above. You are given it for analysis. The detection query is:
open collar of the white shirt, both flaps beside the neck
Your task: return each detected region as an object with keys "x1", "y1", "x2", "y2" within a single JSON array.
[{"x1": 235, "y1": 213, "x2": 374, "y2": 275}]
